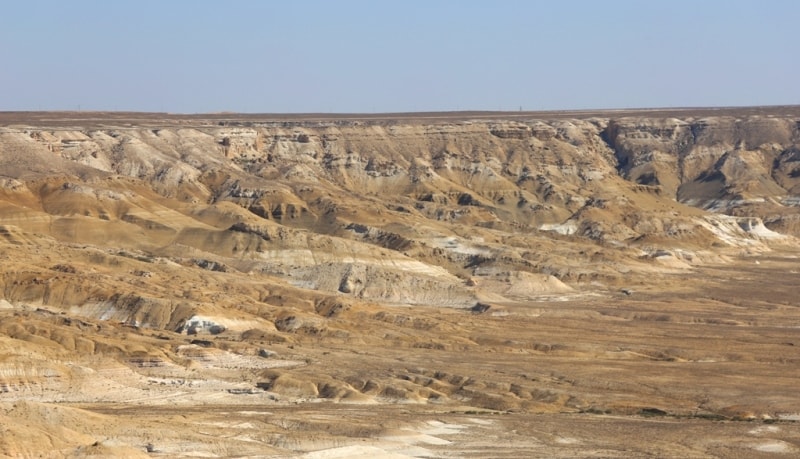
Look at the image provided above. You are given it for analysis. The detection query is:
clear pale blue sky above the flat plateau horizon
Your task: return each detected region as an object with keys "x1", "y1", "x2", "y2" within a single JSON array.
[{"x1": 0, "y1": 0, "x2": 800, "y2": 113}]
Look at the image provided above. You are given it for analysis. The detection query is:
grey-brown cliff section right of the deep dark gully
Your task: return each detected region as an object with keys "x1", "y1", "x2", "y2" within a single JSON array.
[{"x1": 606, "y1": 116, "x2": 800, "y2": 233}]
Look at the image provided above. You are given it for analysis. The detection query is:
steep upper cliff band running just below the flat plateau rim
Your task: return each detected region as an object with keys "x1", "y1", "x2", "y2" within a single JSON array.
[{"x1": 3, "y1": 116, "x2": 800, "y2": 225}]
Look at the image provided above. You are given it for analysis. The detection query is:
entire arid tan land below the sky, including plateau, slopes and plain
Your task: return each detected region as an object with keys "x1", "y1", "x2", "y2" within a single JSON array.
[{"x1": 0, "y1": 107, "x2": 800, "y2": 458}]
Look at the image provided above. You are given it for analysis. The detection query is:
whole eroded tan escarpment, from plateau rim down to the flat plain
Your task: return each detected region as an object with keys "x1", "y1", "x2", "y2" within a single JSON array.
[{"x1": 0, "y1": 115, "x2": 800, "y2": 316}]
